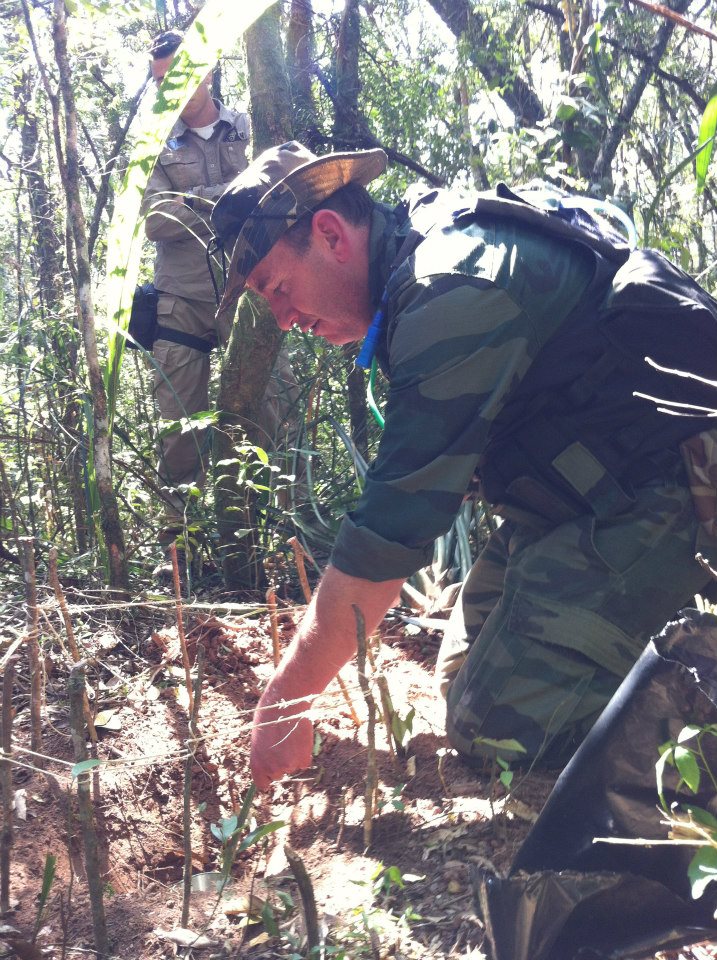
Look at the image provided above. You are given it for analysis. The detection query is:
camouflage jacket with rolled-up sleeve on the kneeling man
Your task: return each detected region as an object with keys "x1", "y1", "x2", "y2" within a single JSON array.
[{"x1": 331, "y1": 197, "x2": 593, "y2": 581}]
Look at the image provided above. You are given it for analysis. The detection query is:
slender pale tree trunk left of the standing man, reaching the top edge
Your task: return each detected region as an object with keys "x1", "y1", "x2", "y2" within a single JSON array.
[{"x1": 52, "y1": 0, "x2": 129, "y2": 595}]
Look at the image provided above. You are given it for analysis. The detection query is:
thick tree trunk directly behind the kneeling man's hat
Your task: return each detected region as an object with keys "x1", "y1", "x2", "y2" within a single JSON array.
[{"x1": 213, "y1": 4, "x2": 292, "y2": 590}]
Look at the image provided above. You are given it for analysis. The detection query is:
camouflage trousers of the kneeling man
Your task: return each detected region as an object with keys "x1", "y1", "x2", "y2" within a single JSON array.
[{"x1": 437, "y1": 468, "x2": 709, "y2": 763}]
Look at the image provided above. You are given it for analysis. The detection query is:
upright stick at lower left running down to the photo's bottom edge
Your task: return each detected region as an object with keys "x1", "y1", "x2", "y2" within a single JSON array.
[{"x1": 67, "y1": 660, "x2": 109, "y2": 958}]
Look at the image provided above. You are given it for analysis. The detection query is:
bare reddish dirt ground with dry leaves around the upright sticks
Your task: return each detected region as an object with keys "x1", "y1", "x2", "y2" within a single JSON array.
[{"x1": 0, "y1": 584, "x2": 717, "y2": 960}]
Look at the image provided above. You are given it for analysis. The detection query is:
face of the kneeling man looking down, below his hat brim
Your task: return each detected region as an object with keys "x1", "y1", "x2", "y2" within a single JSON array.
[{"x1": 246, "y1": 222, "x2": 371, "y2": 344}]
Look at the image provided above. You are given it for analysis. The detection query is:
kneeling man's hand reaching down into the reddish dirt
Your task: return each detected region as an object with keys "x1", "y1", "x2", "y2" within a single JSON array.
[{"x1": 251, "y1": 687, "x2": 314, "y2": 790}]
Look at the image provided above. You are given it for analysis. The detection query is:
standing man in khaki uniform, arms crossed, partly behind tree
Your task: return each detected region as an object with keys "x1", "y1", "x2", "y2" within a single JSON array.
[{"x1": 142, "y1": 30, "x2": 297, "y2": 579}]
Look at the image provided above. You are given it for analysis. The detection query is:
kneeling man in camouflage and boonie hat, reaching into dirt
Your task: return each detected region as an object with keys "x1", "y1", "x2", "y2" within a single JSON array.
[{"x1": 213, "y1": 143, "x2": 717, "y2": 788}]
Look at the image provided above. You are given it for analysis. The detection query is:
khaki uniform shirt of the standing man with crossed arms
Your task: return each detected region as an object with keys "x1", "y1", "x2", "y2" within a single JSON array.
[{"x1": 142, "y1": 104, "x2": 250, "y2": 303}]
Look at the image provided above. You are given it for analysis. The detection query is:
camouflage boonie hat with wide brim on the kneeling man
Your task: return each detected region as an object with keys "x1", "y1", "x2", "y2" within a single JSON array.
[{"x1": 211, "y1": 140, "x2": 388, "y2": 316}]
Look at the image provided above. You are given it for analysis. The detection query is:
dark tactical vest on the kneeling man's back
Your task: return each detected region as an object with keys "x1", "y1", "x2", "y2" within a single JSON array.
[{"x1": 448, "y1": 186, "x2": 717, "y2": 522}]
